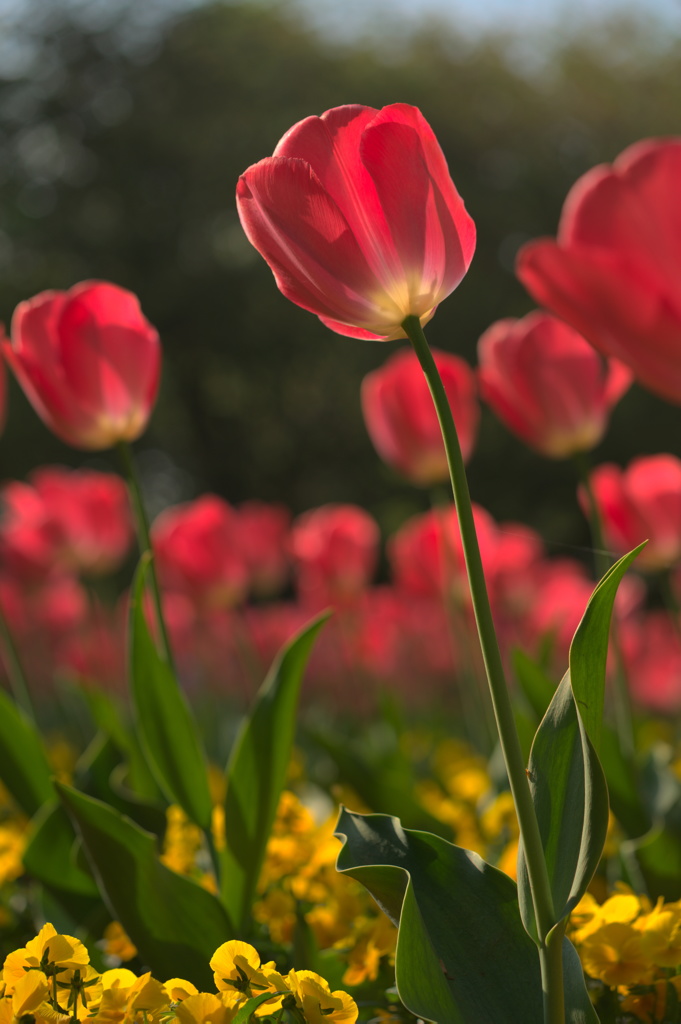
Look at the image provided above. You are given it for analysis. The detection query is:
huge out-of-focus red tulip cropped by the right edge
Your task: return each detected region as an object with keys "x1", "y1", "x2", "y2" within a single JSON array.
[{"x1": 517, "y1": 138, "x2": 681, "y2": 401}]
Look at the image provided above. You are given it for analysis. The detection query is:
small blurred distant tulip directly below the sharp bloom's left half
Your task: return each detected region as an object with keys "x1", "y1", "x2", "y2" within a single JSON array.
[{"x1": 291, "y1": 505, "x2": 380, "y2": 607}]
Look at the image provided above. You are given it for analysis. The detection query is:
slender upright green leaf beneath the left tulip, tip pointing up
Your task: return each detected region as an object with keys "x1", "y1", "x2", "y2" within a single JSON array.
[{"x1": 130, "y1": 557, "x2": 213, "y2": 831}]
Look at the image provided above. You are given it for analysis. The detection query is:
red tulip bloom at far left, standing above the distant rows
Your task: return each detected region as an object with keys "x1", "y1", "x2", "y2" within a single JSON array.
[{"x1": 2, "y1": 282, "x2": 161, "y2": 451}]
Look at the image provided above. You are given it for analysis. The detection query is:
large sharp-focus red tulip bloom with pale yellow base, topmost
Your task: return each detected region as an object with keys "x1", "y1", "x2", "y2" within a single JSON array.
[{"x1": 237, "y1": 103, "x2": 475, "y2": 340}]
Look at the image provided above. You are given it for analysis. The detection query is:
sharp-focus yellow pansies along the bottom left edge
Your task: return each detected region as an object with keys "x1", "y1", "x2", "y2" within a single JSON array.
[{"x1": 0, "y1": 924, "x2": 357, "y2": 1024}]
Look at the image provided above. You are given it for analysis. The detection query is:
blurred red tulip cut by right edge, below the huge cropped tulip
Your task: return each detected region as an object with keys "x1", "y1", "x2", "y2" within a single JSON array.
[{"x1": 580, "y1": 455, "x2": 681, "y2": 571}]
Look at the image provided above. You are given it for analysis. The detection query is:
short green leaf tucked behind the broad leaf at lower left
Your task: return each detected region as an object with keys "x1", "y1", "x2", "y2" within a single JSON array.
[{"x1": 22, "y1": 799, "x2": 98, "y2": 897}]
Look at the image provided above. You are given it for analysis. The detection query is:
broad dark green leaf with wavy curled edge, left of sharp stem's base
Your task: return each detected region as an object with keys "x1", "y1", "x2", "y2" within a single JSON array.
[{"x1": 336, "y1": 810, "x2": 544, "y2": 1024}]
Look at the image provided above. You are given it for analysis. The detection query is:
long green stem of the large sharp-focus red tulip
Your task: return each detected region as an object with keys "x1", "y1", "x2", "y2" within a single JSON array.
[{"x1": 401, "y1": 316, "x2": 564, "y2": 1024}]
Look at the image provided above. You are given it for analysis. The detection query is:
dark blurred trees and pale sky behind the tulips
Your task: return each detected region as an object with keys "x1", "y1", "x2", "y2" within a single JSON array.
[{"x1": 0, "y1": 0, "x2": 681, "y2": 552}]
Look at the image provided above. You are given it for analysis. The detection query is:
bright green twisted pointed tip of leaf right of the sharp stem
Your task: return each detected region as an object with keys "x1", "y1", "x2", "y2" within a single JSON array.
[{"x1": 569, "y1": 544, "x2": 645, "y2": 751}]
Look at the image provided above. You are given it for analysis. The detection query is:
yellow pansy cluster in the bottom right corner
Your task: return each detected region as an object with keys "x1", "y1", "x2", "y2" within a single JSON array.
[{"x1": 570, "y1": 885, "x2": 681, "y2": 1024}]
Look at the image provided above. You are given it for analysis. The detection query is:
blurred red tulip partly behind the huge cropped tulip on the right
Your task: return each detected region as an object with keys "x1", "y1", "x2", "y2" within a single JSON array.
[{"x1": 478, "y1": 312, "x2": 632, "y2": 459}]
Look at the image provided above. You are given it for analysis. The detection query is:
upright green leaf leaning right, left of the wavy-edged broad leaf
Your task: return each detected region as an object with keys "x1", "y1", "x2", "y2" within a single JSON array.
[{"x1": 221, "y1": 613, "x2": 329, "y2": 934}]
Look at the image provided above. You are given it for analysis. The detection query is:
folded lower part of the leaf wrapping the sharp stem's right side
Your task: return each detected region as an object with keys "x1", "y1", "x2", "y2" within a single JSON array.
[{"x1": 518, "y1": 673, "x2": 608, "y2": 937}]
